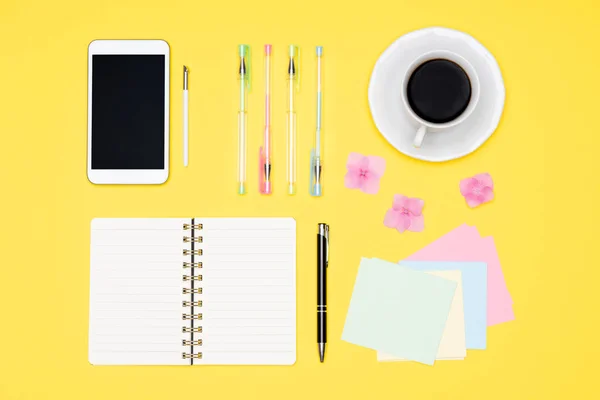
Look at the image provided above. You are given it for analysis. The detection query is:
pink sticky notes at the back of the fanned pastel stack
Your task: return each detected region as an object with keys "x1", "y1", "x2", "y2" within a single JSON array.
[{"x1": 407, "y1": 225, "x2": 515, "y2": 326}]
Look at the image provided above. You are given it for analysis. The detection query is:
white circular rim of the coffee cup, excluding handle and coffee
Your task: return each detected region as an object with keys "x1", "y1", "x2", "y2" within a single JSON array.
[{"x1": 401, "y1": 49, "x2": 480, "y2": 129}]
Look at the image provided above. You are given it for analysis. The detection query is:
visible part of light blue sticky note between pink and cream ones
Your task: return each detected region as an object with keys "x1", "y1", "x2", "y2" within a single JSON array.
[{"x1": 399, "y1": 261, "x2": 487, "y2": 350}]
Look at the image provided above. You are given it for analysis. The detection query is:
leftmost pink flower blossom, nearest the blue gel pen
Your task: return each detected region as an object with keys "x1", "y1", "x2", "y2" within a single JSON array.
[{"x1": 344, "y1": 153, "x2": 385, "y2": 194}]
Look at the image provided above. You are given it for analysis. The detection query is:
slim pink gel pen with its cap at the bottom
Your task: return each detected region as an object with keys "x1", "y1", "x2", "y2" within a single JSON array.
[{"x1": 258, "y1": 44, "x2": 272, "y2": 194}]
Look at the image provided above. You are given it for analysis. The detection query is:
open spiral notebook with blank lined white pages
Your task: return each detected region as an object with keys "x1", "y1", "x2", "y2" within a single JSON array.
[{"x1": 89, "y1": 218, "x2": 296, "y2": 365}]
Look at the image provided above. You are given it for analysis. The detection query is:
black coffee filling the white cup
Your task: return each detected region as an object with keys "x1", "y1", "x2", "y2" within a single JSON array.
[{"x1": 406, "y1": 59, "x2": 471, "y2": 124}]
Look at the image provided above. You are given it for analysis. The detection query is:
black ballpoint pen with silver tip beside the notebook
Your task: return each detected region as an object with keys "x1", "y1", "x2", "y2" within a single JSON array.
[{"x1": 317, "y1": 224, "x2": 329, "y2": 362}]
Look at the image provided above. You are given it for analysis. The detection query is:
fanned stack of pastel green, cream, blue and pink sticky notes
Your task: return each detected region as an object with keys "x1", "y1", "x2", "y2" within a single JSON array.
[{"x1": 342, "y1": 225, "x2": 514, "y2": 365}]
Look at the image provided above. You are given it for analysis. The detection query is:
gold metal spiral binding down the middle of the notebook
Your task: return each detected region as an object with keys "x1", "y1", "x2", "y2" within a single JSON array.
[{"x1": 181, "y1": 219, "x2": 203, "y2": 364}]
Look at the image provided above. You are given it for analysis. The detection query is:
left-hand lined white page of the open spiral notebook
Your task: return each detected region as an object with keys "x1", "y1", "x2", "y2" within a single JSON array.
[{"x1": 89, "y1": 218, "x2": 190, "y2": 365}]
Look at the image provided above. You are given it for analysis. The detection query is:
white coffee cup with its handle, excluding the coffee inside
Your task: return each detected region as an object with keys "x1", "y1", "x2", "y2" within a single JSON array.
[{"x1": 402, "y1": 50, "x2": 479, "y2": 147}]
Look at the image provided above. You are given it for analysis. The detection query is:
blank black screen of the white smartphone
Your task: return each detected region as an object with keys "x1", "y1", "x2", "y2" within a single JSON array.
[{"x1": 92, "y1": 55, "x2": 165, "y2": 169}]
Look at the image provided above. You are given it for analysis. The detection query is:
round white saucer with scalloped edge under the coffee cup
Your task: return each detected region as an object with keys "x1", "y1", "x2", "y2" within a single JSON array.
[{"x1": 369, "y1": 28, "x2": 505, "y2": 161}]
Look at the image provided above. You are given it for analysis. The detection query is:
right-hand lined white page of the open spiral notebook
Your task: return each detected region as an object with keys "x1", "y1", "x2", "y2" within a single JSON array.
[{"x1": 194, "y1": 218, "x2": 296, "y2": 365}]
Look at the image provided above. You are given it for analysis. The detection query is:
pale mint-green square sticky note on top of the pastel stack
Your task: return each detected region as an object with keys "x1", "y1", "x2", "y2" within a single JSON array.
[{"x1": 342, "y1": 258, "x2": 457, "y2": 365}]
